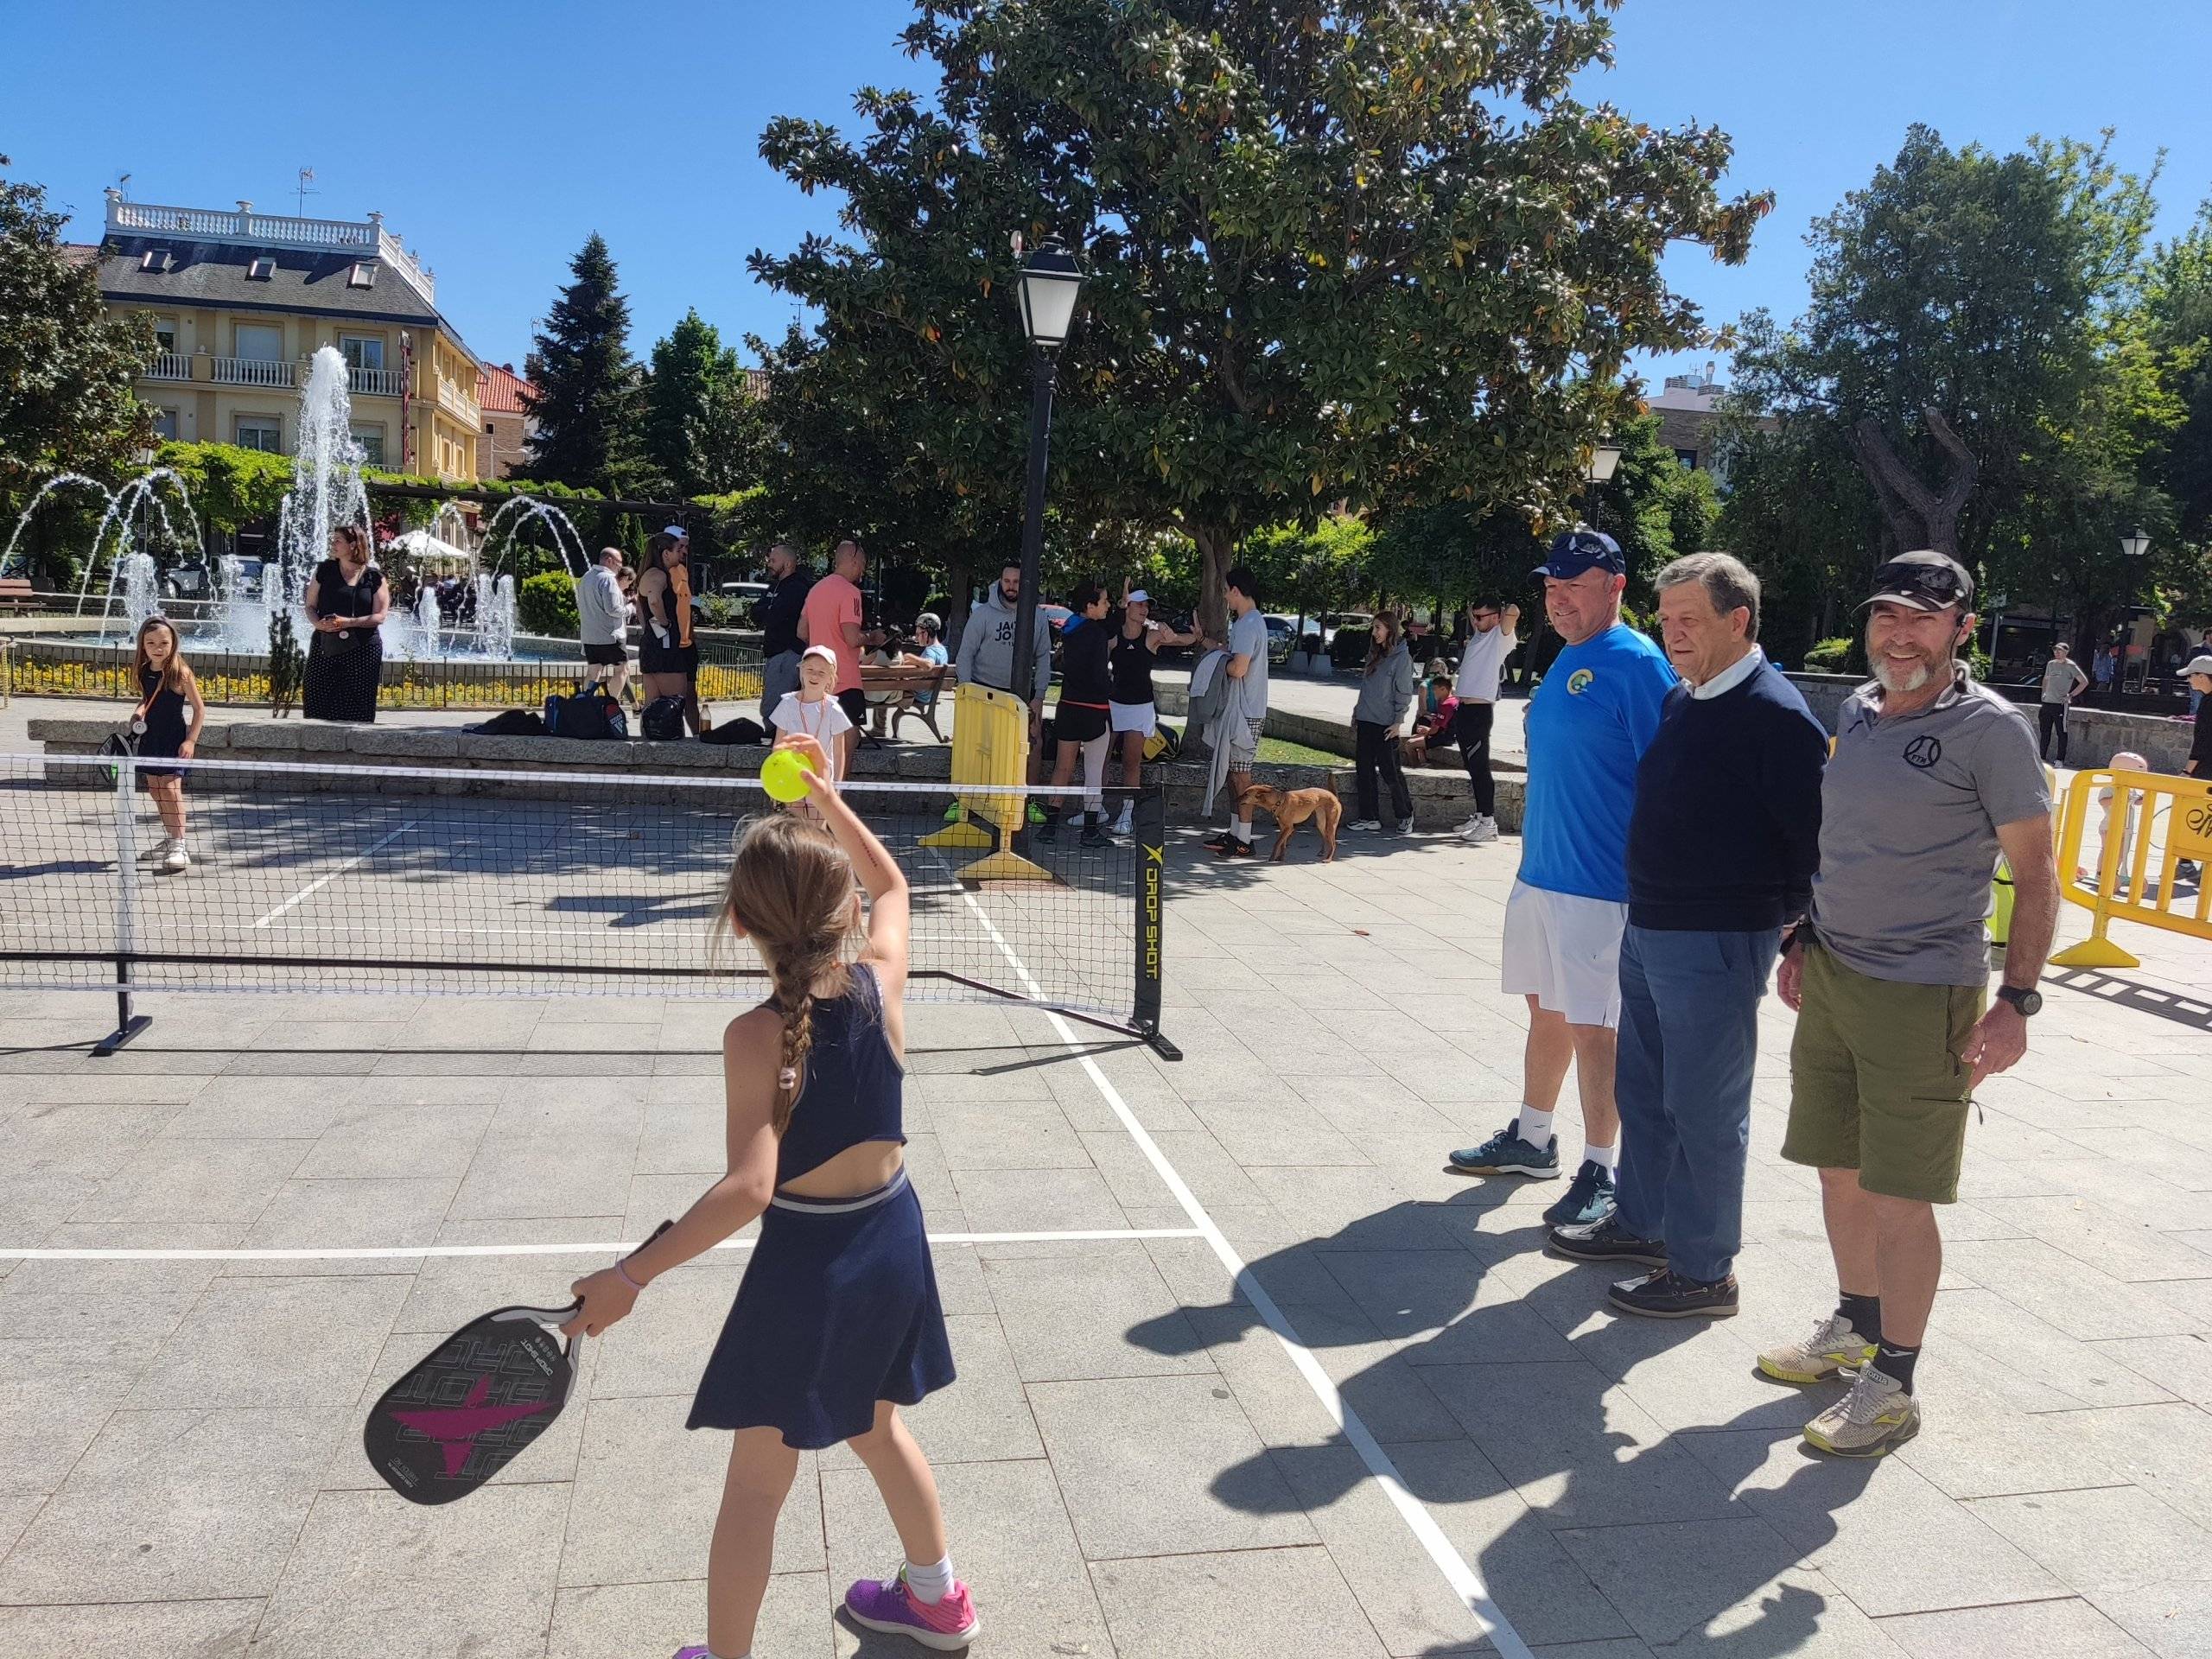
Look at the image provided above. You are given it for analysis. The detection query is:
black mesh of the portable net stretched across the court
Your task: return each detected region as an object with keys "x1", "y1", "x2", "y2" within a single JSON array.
[{"x1": 0, "y1": 754, "x2": 1144, "y2": 1024}]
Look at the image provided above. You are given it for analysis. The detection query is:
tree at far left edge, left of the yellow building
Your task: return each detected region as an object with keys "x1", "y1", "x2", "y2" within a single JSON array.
[{"x1": 0, "y1": 155, "x2": 155, "y2": 559}]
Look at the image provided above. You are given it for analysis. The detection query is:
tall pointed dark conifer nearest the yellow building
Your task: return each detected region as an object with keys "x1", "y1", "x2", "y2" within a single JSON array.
[{"x1": 526, "y1": 230, "x2": 644, "y2": 493}]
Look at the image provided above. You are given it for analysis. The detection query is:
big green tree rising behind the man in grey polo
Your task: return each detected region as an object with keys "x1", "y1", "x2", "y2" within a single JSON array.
[{"x1": 1737, "y1": 126, "x2": 2152, "y2": 564}]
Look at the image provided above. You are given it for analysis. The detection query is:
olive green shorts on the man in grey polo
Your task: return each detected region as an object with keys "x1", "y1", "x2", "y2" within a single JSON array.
[{"x1": 1783, "y1": 944, "x2": 1988, "y2": 1204}]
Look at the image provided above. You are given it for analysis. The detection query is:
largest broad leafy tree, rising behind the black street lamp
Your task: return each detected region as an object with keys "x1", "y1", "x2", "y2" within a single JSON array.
[{"x1": 754, "y1": 0, "x2": 1767, "y2": 621}]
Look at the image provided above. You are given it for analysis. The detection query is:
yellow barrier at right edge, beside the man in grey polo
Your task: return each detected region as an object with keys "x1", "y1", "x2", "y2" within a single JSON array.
[{"x1": 2050, "y1": 770, "x2": 2212, "y2": 967}]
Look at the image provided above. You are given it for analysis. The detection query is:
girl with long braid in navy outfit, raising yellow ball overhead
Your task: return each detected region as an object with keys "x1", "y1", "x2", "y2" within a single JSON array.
[{"x1": 562, "y1": 734, "x2": 978, "y2": 1659}]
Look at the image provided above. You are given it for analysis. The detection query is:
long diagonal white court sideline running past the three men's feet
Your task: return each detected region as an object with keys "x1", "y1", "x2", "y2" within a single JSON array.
[{"x1": 938, "y1": 862, "x2": 1535, "y2": 1659}]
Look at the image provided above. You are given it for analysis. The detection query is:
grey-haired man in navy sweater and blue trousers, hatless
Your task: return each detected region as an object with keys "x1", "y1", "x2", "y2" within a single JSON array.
[{"x1": 1546, "y1": 553, "x2": 1827, "y2": 1319}]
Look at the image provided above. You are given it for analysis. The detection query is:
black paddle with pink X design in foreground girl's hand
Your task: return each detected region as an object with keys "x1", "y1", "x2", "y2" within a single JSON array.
[{"x1": 360, "y1": 1221, "x2": 675, "y2": 1504}]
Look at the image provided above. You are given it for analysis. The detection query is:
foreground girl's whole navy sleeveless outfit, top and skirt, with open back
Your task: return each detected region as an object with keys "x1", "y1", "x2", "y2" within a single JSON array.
[{"x1": 683, "y1": 963, "x2": 953, "y2": 1451}]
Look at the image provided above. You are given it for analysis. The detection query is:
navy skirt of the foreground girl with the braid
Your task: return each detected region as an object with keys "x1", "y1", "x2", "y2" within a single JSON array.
[{"x1": 683, "y1": 1170, "x2": 953, "y2": 1451}]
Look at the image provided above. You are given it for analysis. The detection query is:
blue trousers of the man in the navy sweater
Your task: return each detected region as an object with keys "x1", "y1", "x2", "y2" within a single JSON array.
[{"x1": 1612, "y1": 927, "x2": 1781, "y2": 1281}]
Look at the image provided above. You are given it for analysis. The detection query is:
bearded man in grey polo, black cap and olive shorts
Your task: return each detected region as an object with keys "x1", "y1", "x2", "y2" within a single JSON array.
[{"x1": 1758, "y1": 553, "x2": 2059, "y2": 1458}]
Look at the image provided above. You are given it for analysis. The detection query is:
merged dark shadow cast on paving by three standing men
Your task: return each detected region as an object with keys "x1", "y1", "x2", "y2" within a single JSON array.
[{"x1": 1128, "y1": 1185, "x2": 1873, "y2": 1659}]
